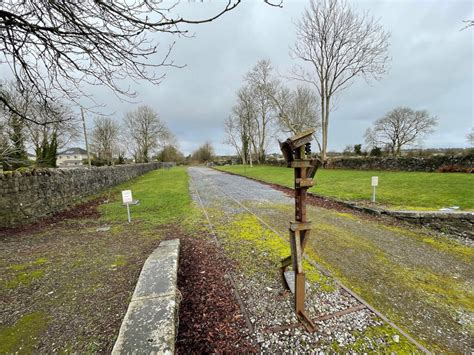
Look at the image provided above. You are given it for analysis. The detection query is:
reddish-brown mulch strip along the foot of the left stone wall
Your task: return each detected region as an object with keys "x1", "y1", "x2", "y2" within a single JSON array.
[{"x1": 0, "y1": 198, "x2": 104, "y2": 237}]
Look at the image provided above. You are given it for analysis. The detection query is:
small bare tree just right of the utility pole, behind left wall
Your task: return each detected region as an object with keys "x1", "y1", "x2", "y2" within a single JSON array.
[{"x1": 91, "y1": 116, "x2": 120, "y2": 165}]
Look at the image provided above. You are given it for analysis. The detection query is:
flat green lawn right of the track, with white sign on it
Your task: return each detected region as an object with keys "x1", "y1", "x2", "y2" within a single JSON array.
[{"x1": 218, "y1": 165, "x2": 474, "y2": 210}]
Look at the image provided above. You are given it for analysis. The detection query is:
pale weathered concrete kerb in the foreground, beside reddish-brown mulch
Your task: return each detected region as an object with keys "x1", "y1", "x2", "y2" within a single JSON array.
[{"x1": 112, "y1": 239, "x2": 180, "y2": 354}]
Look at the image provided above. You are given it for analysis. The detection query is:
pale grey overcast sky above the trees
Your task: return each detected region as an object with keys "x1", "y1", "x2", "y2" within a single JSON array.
[{"x1": 82, "y1": 0, "x2": 474, "y2": 154}]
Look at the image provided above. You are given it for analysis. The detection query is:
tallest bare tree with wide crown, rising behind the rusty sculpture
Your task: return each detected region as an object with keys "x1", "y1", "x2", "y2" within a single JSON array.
[{"x1": 292, "y1": 0, "x2": 389, "y2": 161}]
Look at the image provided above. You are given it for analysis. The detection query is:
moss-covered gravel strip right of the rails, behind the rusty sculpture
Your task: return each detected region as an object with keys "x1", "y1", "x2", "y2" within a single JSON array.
[{"x1": 192, "y1": 169, "x2": 474, "y2": 353}]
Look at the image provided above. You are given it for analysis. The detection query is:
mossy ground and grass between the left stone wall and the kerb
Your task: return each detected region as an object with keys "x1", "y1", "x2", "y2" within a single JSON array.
[{"x1": 0, "y1": 168, "x2": 194, "y2": 354}]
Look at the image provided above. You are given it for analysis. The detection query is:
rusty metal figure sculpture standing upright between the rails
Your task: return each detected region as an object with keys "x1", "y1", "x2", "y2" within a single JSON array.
[{"x1": 280, "y1": 130, "x2": 320, "y2": 332}]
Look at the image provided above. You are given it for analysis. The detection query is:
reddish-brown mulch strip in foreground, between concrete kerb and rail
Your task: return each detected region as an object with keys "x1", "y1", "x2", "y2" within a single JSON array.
[{"x1": 176, "y1": 236, "x2": 258, "y2": 354}]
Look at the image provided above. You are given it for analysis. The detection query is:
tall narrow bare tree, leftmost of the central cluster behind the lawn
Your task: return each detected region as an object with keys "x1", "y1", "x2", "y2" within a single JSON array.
[{"x1": 244, "y1": 60, "x2": 280, "y2": 163}]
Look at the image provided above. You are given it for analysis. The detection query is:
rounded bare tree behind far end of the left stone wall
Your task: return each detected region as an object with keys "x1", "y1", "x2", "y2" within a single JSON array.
[{"x1": 123, "y1": 106, "x2": 171, "y2": 163}]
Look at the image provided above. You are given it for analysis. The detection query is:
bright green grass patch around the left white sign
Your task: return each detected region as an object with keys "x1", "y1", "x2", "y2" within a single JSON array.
[{"x1": 100, "y1": 167, "x2": 191, "y2": 226}]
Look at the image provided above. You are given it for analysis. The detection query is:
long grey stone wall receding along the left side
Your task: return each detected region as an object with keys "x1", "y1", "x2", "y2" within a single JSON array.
[{"x1": 0, "y1": 163, "x2": 168, "y2": 228}]
